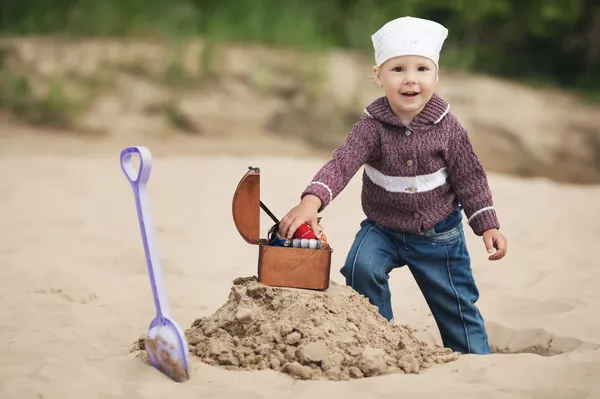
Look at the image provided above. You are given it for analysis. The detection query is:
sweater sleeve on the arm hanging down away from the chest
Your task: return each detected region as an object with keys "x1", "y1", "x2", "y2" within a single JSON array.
[{"x1": 446, "y1": 121, "x2": 500, "y2": 236}]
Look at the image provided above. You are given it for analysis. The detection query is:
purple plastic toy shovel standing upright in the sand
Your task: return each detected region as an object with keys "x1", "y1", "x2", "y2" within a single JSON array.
[{"x1": 121, "y1": 147, "x2": 189, "y2": 382}]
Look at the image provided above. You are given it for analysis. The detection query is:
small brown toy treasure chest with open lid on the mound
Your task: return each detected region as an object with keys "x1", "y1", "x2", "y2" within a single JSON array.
[{"x1": 232, "y1": 167, "x2": 333, "y2": 290}]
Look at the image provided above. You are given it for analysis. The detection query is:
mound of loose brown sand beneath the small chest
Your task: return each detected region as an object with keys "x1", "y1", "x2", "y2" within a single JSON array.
[{"x1": 180, "y1": 277, "x2": 459, "y2": 380}]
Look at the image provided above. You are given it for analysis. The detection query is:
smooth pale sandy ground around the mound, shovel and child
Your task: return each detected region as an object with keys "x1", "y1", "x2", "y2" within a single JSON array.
[{"x1": 0, "y1": 135, "x2": 600, "y2": 399}]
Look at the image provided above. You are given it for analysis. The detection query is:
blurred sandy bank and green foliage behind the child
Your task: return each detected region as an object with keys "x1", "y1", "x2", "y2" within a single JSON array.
[{"x1": 0, "y1": 0, "x2": 600, "y2": 183}]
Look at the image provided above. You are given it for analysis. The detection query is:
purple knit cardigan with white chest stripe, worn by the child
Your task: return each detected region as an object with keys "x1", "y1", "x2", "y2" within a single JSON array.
[{"x1": 302, "y1": 94, "x2": 500, "y2": 236}]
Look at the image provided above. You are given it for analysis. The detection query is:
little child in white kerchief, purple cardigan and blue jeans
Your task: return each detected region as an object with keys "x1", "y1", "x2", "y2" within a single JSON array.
[{"x1": 280, "y1": 17, "x2": 506, "y2": 354}]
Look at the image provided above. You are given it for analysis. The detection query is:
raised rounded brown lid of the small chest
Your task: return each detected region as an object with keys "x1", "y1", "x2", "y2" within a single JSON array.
[{"x1": 232, "y1": 166, "x2": 260, "y2": 244}]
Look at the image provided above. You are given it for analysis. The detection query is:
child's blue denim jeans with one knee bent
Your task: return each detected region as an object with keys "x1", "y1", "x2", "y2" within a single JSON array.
[{"x1": 340, "y1": 208, "x2": 490, "y2": 354}]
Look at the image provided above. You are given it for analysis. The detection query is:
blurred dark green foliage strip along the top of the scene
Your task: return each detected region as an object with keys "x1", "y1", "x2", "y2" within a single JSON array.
[{"x1": 0, "y1": 0, "x2": 600, "y2": 92}]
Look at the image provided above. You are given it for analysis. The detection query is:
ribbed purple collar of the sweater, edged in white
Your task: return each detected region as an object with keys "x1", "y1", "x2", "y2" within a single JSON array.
[{"x1": 365, "y1": 93, "x2": 450, "y2": 128}]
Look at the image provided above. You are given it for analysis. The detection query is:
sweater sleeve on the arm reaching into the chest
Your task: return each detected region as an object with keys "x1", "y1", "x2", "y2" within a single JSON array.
[{"x1": 301, "y1": 116, "x2": 380, "y2": 212}]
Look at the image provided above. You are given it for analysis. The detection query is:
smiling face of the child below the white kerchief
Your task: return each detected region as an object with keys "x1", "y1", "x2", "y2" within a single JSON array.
[{"x1": 373, "y1": 55, "x2": 438, "y2": 123}]
